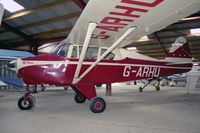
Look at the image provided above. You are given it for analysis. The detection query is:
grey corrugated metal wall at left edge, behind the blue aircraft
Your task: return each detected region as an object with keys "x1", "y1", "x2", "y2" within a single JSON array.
[{"x1": 0, "y1": 59, "x2": 23, "y2": 90}]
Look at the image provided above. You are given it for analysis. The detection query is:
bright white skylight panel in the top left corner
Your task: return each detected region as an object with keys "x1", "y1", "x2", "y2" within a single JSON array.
[{"x1": 0, "y1": 0, "x2": 24, "y2": 13}]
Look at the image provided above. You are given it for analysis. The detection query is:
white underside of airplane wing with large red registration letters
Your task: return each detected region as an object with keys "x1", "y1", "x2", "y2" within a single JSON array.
[{"x1": 66, "y1": 0, "x2": 200, "y2": 47}]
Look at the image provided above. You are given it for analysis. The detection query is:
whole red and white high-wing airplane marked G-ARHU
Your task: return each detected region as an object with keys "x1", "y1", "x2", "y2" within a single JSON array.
[{"x1": 6, "y1": 0, "x2": 200, "y2": 113}]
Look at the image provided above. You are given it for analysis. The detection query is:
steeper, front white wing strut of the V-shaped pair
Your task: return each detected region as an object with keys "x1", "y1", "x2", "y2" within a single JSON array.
[{"x1": 73, "y1": 22, "x2": 97, "y2": 84}]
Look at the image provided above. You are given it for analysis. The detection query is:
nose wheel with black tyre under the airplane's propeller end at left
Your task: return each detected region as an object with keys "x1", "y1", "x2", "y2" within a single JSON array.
[{"x1": 18, "y1": 96, "x2": 34, "y2": 110}]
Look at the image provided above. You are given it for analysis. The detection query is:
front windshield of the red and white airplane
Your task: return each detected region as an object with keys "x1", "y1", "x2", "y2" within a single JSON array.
[{"x1": 51, "y1": 41, "x2": 70, "y2": 57}]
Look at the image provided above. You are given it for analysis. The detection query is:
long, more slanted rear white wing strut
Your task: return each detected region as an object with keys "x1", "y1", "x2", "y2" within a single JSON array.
[{"x1": 74, "y1": 26, "x2": 137, "y2": 84}]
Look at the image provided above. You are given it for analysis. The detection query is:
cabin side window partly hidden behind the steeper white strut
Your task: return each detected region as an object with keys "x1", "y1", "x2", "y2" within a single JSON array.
[{"x1": 79, "y1": 46, "x2": 98, "y2": 59}]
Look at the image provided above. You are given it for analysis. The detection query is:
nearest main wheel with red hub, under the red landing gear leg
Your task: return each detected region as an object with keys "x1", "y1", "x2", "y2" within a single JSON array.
[{"x1": 90, "y1": 97, "x2": 106, "y2": 113}]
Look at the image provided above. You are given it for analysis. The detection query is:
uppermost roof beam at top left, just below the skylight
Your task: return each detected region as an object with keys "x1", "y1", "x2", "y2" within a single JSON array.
[{"x1": 3, "y1": 0, "x2": 72, "y2": 21}]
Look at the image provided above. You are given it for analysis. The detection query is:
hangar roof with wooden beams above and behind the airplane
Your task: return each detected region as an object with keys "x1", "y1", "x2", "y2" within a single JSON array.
[{"x1": 0, "y1": 0, "x2": 200, "y2": 61}]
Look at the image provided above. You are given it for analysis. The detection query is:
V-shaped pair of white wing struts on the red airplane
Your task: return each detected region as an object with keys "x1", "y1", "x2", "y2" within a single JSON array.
[{"x1": 73, "y1": 22, "x2": 137, "y2": 84}]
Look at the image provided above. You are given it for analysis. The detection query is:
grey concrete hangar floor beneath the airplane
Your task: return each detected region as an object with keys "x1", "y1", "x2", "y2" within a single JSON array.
[{"x1": 0, "y1": 85, "x2": 200, "y2": 133}]
